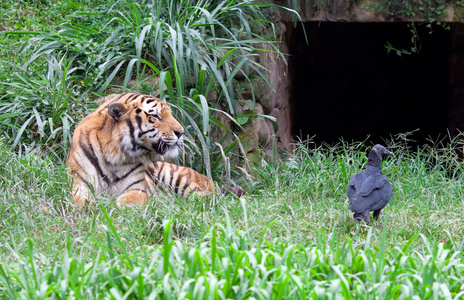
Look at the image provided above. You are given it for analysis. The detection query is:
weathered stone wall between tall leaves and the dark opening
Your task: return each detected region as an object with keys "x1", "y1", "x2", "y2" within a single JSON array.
[{"x1": 212, "y1": 12, "x2": 293, "y2": 162}]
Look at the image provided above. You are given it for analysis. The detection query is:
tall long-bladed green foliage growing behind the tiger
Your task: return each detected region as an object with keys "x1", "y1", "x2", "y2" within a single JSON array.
[{"x1": 0, "y1": 0, "x2": 292, "y2": 175}]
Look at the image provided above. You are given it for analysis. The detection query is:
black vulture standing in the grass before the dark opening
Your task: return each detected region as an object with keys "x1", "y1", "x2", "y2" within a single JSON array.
[{"x1": 347, "y1": 145, "x2": 393, "y2": 223}]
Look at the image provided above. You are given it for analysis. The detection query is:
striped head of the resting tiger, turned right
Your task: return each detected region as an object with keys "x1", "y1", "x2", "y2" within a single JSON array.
[{"x1": 103, "y1": 93, "x2": 184, "y2": 158}]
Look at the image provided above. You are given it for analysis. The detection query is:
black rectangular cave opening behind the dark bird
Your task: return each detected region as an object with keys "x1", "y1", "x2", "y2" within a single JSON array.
[{"x1": 288, "y1": 22, "x2": 452, "y2": 145}]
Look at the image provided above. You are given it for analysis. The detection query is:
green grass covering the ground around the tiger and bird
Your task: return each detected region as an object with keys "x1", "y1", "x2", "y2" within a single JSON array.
[{"x1": 0, "y1": 142, "x2": 464, "y2": 299}]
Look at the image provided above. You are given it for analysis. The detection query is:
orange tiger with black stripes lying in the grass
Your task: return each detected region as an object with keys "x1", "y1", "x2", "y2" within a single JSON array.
[{"x1": 66, "y1": 93, "x2": 215, "y2": 207}]
